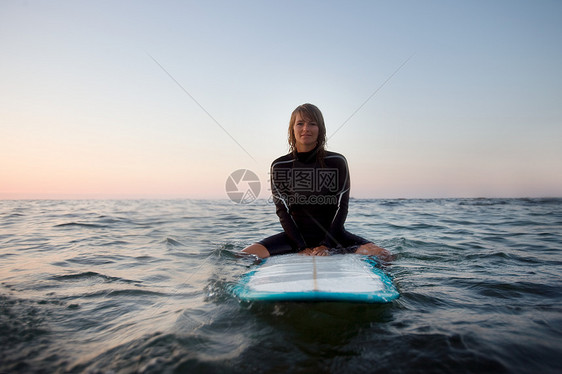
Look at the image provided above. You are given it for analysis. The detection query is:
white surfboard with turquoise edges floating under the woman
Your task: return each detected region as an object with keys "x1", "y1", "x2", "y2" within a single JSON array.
[{"x1": 233, "y1": 254, "x2": 400, "y2": 303}]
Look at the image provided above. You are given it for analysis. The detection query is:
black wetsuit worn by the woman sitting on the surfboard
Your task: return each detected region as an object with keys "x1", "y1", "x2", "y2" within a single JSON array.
[{"x1": 259, "y1": 150, "x2": 369, "y2": 255}]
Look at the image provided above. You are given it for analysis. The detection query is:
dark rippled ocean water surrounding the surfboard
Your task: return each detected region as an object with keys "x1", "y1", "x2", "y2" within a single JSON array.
[{"x1": 0, "y1": 199, "x2": 562, "y2": 373}]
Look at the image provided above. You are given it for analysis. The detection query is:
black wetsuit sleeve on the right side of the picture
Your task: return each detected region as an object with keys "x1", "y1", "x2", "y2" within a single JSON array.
[{"x1": 321, "y1": 156, "x2": 351, "y2": 248}]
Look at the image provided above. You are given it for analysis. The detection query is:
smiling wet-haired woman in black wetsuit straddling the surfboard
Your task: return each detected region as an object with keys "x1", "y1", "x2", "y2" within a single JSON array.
[{"x1": 243, "y1": 104, "x2": 391, "y2": 259}]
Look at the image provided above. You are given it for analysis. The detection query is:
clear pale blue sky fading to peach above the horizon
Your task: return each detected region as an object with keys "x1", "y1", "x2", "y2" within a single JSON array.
[{"x1": 0, "y1": 0, "x2": 562, "y2": 199}]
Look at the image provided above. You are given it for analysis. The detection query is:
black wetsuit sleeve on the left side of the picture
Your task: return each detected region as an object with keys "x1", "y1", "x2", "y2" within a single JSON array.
[{"x1": 271, "y1": 165, "x2": 307, "y2": 251}]
